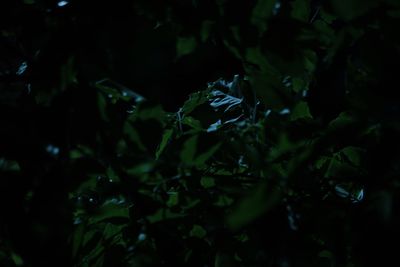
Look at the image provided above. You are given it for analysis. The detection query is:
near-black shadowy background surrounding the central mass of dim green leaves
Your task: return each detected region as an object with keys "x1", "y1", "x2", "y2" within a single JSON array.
[{"x1": 0, "y1": 0, "x2": 400, "y2": 266}]
